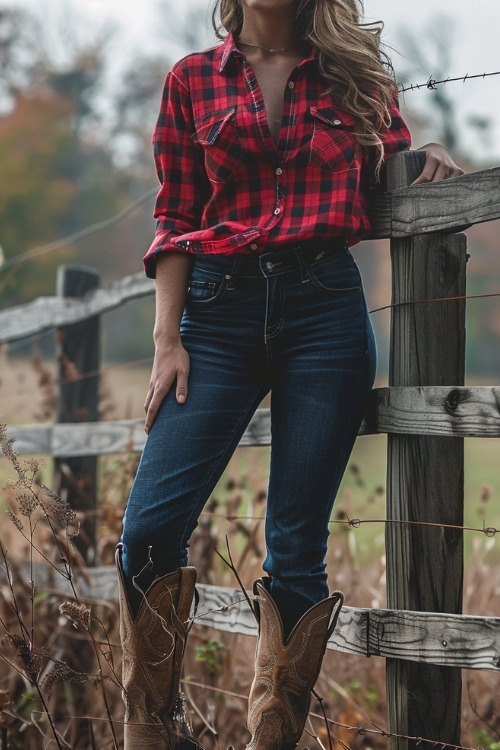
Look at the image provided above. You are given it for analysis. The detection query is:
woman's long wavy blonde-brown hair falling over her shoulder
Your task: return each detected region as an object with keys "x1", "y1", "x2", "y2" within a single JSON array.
[{"x1": 212, "y1": 0, "x2": 396, "y2": 171}]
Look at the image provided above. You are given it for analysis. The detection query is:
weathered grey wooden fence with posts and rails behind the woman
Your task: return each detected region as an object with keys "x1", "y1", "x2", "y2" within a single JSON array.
[{"x1": 0, "y1": 151, "x2": 500, "y2": 750}]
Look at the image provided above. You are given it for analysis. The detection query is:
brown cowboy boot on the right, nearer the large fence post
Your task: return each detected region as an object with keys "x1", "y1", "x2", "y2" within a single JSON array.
[{"x1": 247, "y1": 579, "x2": 344, "y2": 750}]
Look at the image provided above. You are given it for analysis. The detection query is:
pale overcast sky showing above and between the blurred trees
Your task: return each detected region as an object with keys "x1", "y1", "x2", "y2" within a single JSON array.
[{"x1": 0, "y1": 0, "x2": 500, "y2": 163}]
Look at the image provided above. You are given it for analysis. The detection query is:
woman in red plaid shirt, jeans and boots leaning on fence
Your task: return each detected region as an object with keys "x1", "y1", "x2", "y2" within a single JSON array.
[{"x1": 117, "y1": 0, "x2": 461, "y2": 750}]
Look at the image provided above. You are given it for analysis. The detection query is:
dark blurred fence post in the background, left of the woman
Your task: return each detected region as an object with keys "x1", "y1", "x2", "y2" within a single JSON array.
[{"x1": 55, "y1": 266, "x2": 100, "y2": 565}]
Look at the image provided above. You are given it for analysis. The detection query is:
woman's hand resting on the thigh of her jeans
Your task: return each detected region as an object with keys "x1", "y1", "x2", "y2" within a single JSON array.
[{"x1": 144, "y1": 337, "x2": 189, "y2": 433}]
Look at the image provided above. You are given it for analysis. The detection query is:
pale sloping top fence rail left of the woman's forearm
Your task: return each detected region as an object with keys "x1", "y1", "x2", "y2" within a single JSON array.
[{"x1": 0, "y1": 273, "x2": 154, "y2": 343}]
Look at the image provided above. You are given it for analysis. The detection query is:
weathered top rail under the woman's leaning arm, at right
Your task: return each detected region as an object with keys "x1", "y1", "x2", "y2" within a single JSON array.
[{"x1": 372, "y1": 166, "x2": 500, "y2": 239}]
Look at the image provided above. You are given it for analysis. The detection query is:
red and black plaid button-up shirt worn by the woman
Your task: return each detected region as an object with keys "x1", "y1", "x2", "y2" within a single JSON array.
[{"x1": 144, "y1": 34, "x2": 410, "y2": 277}]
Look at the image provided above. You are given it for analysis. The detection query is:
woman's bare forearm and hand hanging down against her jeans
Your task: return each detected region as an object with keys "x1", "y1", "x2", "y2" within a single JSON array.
[{"x1": 144, "y1": 252, "x2": 191, "y2": 433}]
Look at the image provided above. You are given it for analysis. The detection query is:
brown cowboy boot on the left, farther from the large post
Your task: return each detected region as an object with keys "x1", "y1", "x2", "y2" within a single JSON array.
[{"x1": 116, "y1": 548, "x2": 201, "y2": 750}]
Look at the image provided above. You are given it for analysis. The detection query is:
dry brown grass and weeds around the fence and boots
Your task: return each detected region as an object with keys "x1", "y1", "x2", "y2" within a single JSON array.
[{"x1": 0, "y1": 354, "x2": 500, "y2": 750}]
